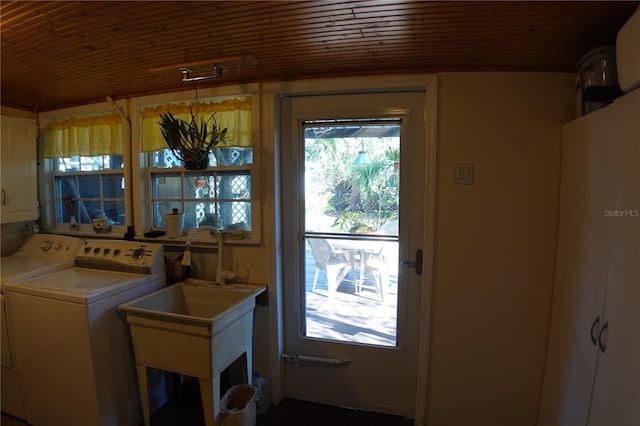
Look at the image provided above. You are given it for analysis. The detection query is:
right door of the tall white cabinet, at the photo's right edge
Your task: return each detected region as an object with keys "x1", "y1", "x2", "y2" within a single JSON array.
[{"x1": 589, "y1": 93, "x2": 640, "y2": 426}]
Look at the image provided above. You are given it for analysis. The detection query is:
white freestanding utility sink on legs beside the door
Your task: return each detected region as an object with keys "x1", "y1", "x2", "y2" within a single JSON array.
[{"x1": 120, "y1": 279, "x2": 266, "y2": 426}]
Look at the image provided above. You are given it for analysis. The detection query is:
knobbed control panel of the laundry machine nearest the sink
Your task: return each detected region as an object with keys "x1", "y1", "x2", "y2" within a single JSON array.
[{"x1": 75, "y1": 240, "x2": 164, "y2": 274}]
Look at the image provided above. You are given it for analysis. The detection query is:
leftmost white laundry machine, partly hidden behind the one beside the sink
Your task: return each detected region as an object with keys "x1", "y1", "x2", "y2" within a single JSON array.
[{"x1": 0, "y1": 234, "x2": 83, "y2": 419}]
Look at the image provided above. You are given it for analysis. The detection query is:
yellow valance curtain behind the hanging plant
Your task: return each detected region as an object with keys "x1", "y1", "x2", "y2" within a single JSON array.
[{"x1": 141, "y1": 96, "x2": 252, "y2": 152}]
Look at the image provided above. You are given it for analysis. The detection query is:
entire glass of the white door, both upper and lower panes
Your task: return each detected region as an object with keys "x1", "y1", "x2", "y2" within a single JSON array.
[{"x1": 302, "y1": 120, "x2": 400, "y2": 347}]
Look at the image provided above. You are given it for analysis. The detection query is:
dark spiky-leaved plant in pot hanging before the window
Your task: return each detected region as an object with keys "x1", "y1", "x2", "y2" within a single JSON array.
[{"x1": 159, "y1": 111, "x2": 228, "y2": 170}]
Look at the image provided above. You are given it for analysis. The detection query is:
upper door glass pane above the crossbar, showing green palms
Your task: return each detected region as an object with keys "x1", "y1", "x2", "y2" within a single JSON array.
[{"x1": 305, "y1": 124, "x2": 400, "y2": 235}]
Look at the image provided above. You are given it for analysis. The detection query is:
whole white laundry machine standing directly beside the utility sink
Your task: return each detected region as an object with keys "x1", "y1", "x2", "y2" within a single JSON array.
[{"x1": 6, "y1": 240, "x2": 166, "y2": 426}]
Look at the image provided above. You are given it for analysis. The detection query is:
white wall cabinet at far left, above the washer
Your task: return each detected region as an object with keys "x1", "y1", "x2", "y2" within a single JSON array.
[{"x1": 0, "y1": 116, "x2": 38, "y2": 223}]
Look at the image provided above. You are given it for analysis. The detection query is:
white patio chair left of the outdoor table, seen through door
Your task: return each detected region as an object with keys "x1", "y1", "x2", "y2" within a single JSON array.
[{"x1": 307, "y1": 238, "x2": 351, "y2": 297}]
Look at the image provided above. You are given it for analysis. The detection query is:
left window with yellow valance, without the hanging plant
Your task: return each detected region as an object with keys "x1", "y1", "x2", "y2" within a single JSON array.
[{"x1": 44, "y1": 113, "x2": 126, "y2": 231}]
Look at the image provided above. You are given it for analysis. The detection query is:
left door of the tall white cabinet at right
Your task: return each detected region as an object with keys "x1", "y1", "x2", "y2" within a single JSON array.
[{"x1": 538, "y1": 111, "x2": 610, "y2": 426}]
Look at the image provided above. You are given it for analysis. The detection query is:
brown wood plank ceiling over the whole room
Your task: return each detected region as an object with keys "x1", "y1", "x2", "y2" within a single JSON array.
[{"x1": 0, "y1": 0, "x2": 640, "y2": 111}]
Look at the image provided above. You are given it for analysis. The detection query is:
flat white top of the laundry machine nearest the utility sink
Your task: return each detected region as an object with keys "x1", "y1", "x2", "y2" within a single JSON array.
[{"x1": 6, "y1": 267, "x2": 163, "y2": 304}]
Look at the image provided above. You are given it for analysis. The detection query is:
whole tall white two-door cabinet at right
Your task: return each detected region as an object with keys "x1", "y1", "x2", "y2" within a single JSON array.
[{"x1": 538, "y1": 90, "x2": 640, "y2": 426}]
